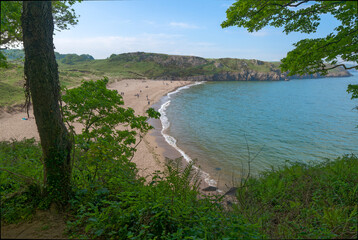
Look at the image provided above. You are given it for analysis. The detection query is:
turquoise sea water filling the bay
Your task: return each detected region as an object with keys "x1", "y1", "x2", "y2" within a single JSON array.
[{"x1": 165, "y1": 75, "x2": 358, "y2": 188}]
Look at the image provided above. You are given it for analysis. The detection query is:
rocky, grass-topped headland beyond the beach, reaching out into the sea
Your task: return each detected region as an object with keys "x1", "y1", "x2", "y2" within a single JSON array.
[{"x1": 108, "y1": 52, "x2": 351, "y2": 81}]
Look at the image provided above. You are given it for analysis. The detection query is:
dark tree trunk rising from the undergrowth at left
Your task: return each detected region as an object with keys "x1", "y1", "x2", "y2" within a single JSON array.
[{"x1": 21, "y1": 1, "x2": 72, "y2": 205}]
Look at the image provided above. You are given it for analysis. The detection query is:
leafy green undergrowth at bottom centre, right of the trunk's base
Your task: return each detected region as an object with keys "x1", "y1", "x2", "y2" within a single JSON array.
[{"x1": 65, "y1": 159, "x2": 260, "y2": 239}]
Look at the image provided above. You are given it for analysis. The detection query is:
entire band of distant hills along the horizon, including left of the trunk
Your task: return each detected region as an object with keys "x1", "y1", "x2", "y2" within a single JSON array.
[{"x1": 4, "y1": 49, "x2": 351, "y2": 81}]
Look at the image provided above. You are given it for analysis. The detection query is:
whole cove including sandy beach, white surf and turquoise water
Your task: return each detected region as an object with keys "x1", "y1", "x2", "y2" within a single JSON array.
[{"x1": 0, "y1": 75, "x2": 358, "y2": 191}]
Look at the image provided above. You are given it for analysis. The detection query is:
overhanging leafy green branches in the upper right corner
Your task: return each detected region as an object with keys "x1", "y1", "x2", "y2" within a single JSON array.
[{"x1": 221, "y1": 0, "x2": 358, "y2": 75}]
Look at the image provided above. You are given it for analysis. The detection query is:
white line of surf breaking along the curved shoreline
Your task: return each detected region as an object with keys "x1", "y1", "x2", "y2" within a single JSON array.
[{"x1": 158, "y1": 81, "x2": 217, "y2": 186}]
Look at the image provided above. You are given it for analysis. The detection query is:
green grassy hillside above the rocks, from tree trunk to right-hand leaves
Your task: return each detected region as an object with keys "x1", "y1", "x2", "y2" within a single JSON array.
[{"x1": 56, "y1": 52, "x2": 279, "y2": 79}]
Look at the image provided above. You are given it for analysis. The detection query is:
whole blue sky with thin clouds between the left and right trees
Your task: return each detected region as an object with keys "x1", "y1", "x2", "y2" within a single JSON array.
[{"x1": 54, "y1": 0, "x2": 337, "y2": 61}]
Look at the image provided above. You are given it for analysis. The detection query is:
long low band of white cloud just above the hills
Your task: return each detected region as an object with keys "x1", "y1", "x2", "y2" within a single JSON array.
[{"x1": 54, "y1": 33, "x2": 286, "y2": 61}]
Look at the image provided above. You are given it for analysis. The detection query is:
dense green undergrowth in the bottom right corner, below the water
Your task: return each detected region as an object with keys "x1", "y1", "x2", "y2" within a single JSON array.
[{"x1": 234, "y1": 155, "x2": 358, "y2": 239}]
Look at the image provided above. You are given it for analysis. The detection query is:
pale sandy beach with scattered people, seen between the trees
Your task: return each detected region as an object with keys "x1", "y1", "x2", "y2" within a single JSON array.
[{"x1": 0, "y1": 80, "x2": 193, "y2": 182}]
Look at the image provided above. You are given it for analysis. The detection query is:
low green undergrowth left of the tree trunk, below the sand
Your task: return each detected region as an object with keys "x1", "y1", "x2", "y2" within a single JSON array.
[{"x1": 0, "y1": 139, "x2": 43, "y2": 223}]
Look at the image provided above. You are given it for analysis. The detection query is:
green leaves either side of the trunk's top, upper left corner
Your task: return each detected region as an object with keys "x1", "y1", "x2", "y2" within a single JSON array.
[{"x1": 0, "y1": 0, "x2": 78, "y2": 67}]
